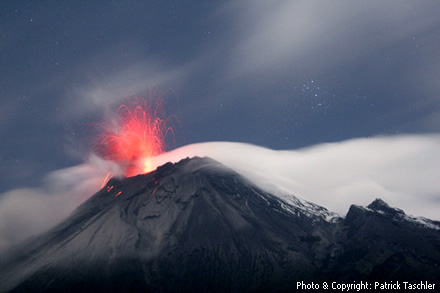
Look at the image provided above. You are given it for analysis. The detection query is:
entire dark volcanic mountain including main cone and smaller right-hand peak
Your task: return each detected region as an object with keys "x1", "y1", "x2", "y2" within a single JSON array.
[{"x1": 0, "y1": 157, "x2": 440, "y2": 292}]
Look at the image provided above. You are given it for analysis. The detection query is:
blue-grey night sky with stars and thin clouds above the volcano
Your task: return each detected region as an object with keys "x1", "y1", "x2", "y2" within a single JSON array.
[{"x1": 0, "y1": 0, "x2": 440, "y2": 191}]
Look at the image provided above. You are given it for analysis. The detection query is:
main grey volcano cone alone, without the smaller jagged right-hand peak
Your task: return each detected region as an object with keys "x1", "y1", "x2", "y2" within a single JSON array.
[{"x1": 1, "y1": 158, "x2": 334, "y2": 291}]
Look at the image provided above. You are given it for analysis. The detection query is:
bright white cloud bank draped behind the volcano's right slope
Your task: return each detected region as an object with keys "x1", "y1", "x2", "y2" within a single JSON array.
[{"x1": 155, "y1": 135, "x2": 440, "y2": 220}]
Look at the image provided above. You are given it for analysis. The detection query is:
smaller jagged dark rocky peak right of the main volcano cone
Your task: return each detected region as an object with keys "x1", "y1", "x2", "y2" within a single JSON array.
[{"x1": 333, "y1": 199, "x2": 440, "y2": 282}]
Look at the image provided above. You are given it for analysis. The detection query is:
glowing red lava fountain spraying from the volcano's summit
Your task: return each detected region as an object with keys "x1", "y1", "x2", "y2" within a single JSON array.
[{"x1": 95, "y1": 92, "x2": 175, "y2": 178}]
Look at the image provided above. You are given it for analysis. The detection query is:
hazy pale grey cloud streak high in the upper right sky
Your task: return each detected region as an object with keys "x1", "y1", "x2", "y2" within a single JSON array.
[{"x1": 230, "y1": 0, "x2": 440, "y2": 76}]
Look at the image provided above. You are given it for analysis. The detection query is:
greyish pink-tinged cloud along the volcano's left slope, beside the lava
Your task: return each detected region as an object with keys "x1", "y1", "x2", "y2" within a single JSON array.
[{"x1": 0, "y1": 156, "x2": 117, "y2": 251}]
